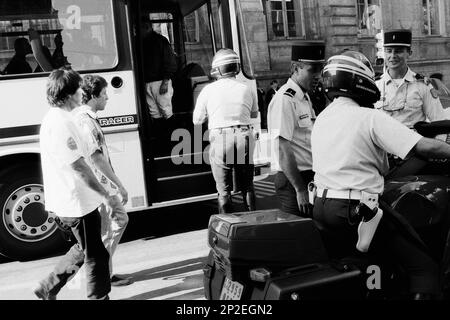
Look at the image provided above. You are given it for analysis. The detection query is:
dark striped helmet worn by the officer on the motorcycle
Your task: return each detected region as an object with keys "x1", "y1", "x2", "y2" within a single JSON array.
[{"x1": 322, "y1": 51, "x2": 380, "y2": 106}]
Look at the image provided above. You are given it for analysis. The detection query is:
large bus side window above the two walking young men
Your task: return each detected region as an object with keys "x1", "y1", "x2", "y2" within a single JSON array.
[{"x1": 0, "y1": 0, "x2": 118, "y2": 74}]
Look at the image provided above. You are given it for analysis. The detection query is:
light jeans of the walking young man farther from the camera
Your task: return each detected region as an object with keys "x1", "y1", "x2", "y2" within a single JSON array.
[{"x1": 99, "y1": 196, "x2": 128, "y2": 275}]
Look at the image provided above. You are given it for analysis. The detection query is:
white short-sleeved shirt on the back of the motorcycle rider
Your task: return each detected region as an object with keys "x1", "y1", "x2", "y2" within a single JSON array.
[{"x1": 311, "y1": 97, "x2": 422, "y2": 194}]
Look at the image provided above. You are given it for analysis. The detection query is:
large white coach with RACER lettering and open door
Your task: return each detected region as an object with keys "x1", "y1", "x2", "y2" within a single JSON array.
[{"x1": 0, "y1": 0, "x2": 268, "y2": 260}]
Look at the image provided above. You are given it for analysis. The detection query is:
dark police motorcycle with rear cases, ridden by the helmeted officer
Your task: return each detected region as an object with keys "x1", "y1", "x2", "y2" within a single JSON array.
[{"x1": 203, "y1": 50, "x2": 450, "y2": 300}]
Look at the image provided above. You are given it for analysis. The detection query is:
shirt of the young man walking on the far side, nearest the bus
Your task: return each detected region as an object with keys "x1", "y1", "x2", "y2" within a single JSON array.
[{"x1": 74, "y1": 105, "x2": 118, "y2": 195}]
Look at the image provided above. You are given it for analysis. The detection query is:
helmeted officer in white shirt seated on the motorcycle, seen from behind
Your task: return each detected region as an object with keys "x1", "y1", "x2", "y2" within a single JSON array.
[{"x1": 311, "y1": 51, "x2": 450, "y2": 299}]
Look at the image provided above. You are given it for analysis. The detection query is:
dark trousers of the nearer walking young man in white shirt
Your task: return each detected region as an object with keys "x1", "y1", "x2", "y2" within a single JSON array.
[{"x1": 40, "y1": 209, "x2": 111, "y2": 299}]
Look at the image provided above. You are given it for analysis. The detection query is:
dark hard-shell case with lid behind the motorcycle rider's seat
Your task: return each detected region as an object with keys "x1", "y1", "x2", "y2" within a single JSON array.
[{"x1": 208, "y1": 209, "x2": 328, "y2": 281}]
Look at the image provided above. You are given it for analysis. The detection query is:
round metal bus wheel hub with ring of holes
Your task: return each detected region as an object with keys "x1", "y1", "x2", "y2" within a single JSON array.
[{"x1": 3, "y1": 184, "x2": 57, "y2": 242}]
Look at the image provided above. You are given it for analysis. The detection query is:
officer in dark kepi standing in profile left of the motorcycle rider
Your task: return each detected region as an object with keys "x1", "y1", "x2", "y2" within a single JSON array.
[{"x1": 267, "y1": 43, "x2": 325, "y2": 216}]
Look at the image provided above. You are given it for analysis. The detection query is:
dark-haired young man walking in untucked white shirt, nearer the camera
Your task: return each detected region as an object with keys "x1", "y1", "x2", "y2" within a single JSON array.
[{"x1": 34, "y1": 69, "x2": 117, "y2": 300}]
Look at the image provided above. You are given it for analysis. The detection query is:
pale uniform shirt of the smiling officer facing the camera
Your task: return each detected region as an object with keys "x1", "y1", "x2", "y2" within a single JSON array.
[{"x1": 375, "y1": 69, "x2": 446, "y2": 128}]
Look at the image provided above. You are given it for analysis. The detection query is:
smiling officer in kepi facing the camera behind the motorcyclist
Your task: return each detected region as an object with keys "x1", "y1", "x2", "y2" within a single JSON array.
[{"x1": 375, "y1": 30, "x2": 446, "y2": 128}]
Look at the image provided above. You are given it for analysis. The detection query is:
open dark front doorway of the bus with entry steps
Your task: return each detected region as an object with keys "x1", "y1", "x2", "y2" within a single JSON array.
[{"x1": 135, "y1": 0, "x2": 225, "y2": 202}]
